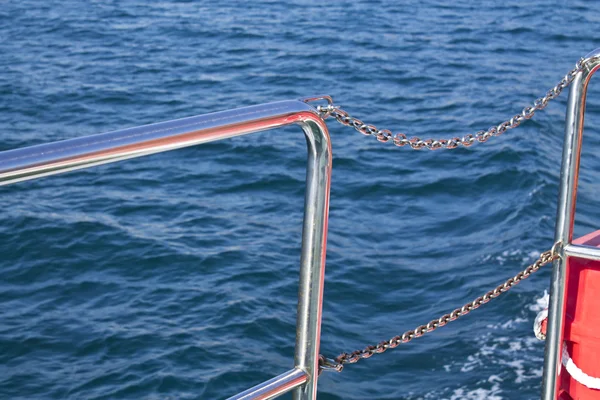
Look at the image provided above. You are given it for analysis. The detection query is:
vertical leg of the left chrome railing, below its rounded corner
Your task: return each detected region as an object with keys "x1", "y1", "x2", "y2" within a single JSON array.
[{"x1": 293, "y1": 118, "x2": 331, "y2": 400}]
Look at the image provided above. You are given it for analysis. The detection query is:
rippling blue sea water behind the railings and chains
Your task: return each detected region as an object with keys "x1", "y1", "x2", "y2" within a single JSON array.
[{"x1": 0, "y1": 0, "x2": 600, "y2": 400}]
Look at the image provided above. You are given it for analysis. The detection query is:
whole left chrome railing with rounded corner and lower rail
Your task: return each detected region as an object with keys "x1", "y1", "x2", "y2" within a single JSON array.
[{"x1": 0, "y1": 100, "x2": 331, "y2": 400}]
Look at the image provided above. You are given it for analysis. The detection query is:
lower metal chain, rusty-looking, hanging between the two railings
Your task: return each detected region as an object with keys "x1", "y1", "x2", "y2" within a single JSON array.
[{"x1": 319, "y1": 242, "x2": 560, "y2": 372}]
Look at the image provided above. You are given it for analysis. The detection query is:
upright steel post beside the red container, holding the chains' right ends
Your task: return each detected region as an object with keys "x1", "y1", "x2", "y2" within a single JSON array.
[{"x1": 542, "y1": 49, "x2": 600, "y2": 400}]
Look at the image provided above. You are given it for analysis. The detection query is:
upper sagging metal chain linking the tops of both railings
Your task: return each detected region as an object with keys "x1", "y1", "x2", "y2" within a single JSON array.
[{"x1": 316, "y1": 58, "x2": 585, "y2": 150}]
